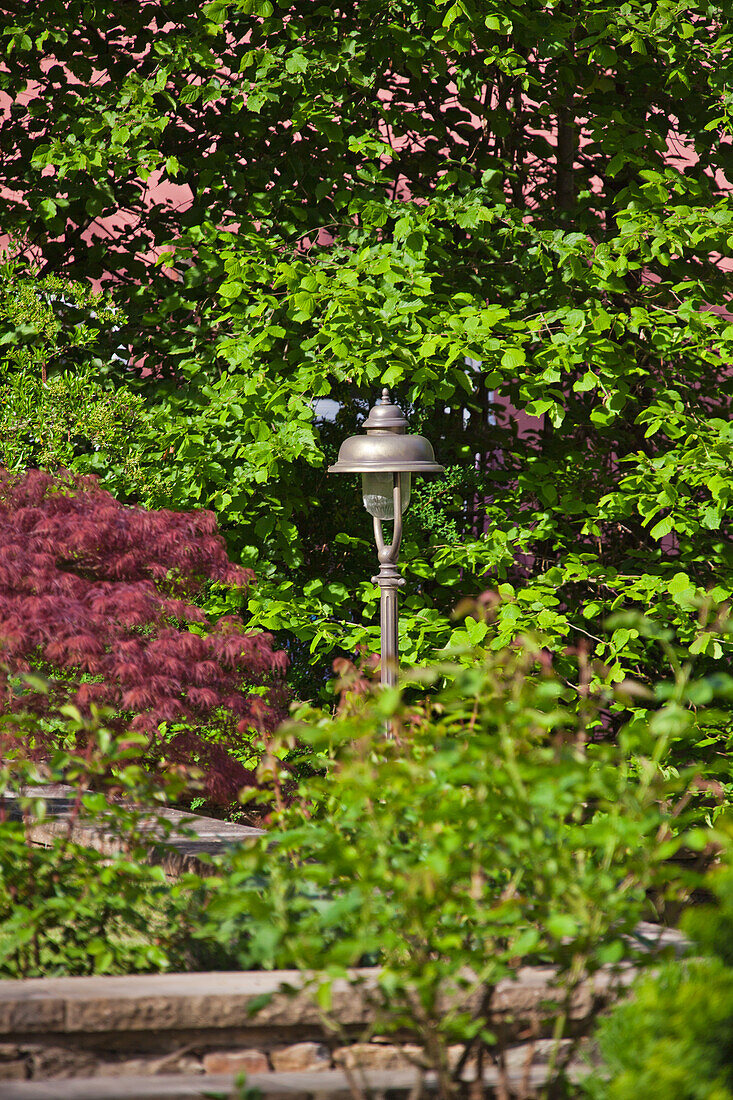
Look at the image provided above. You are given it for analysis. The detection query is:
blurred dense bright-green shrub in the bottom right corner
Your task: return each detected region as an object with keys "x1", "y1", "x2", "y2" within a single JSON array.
[{"x1": 588, "y1": 831, "x2": 733, "y2": 1100}]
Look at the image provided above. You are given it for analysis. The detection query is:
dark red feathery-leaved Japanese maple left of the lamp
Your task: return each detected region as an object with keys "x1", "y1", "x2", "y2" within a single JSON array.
[{"x1": 0, "y1": 470, "x2": 287, "y2": 804}]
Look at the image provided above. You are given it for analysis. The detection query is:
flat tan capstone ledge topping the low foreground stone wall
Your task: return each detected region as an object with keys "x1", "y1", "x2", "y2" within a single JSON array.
[{"x1": 0, "y1": 924, "x2": 685, "y2": 1042}]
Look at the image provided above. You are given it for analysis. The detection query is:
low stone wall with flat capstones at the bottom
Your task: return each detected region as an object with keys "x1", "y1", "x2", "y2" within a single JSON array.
[{"x1": 0, "y1": 968, "x2": 630, "y2": 1097}]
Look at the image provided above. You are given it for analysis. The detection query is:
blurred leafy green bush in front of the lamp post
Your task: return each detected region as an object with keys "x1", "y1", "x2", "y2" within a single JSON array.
[{"x1": 188, "y1": 648, "x2": 686, "y2": 1096}]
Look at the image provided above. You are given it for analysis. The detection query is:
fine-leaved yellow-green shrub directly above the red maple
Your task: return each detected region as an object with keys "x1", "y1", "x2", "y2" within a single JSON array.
[{"x1": 0, "y1": 260, "x2": 157, "y2": 501}]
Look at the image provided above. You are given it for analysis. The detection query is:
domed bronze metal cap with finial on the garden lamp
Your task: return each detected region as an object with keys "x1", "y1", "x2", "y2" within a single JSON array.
[{"x1": 328, "y1": 386, "x2": 445, "y2": 474}]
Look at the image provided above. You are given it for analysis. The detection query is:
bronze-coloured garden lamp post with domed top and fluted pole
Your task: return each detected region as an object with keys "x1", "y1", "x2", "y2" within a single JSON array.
[{"x1": 328, "y1": 386, "x2": 445, "y2": 686}]
